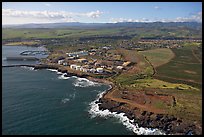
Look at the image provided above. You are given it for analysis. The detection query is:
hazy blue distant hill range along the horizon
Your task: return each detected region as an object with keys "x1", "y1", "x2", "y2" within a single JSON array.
[{"x1": 2, "y1": 22, "x2": 202, "y2": 29}]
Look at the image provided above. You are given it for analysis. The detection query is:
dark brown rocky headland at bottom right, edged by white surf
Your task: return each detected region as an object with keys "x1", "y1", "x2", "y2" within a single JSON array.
[{"x1": 95, "y1": 96, "x2": 202, "y2": 135}]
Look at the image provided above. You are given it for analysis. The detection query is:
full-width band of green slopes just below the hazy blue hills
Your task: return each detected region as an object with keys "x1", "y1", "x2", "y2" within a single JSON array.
[{"x1": 2, "y1": 26, "x2": 202, "y2": 40}]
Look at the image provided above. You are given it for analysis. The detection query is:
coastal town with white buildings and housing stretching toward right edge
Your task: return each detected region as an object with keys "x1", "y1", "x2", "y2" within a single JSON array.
[{"x1": 38, "y1": 39, "x2": 200, "y2": 78}]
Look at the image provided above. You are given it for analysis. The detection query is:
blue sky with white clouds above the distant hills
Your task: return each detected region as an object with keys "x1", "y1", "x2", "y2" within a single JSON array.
[{"x1": 2, "y1": 2, "x2": 202, "y2": 25}]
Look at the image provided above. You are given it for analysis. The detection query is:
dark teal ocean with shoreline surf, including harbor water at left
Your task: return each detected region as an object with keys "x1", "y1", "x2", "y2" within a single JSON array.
[{"x1": 2, "y1": 46, "x2": 162, "y2": 135}]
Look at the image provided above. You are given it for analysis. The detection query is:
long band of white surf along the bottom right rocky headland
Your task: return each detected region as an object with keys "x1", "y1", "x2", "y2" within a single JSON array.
[{"x1": 89, "y1": 91, "x2": 165, "y2": 135}]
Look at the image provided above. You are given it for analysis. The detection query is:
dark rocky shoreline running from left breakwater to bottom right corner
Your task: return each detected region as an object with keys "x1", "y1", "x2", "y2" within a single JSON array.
[{"x1": 2, "y1": 64, "x2": 202, "y2": 135}]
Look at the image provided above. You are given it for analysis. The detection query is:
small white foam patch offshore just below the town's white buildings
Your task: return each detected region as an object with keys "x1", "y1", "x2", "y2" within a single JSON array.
[{"x1": 73, "y1": 77, "x2": 101, "y2": 87}]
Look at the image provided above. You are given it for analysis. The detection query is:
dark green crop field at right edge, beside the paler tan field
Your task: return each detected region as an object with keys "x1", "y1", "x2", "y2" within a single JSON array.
[{"x1": 155, "y1": 46, "x2": 202, "y2": 88}]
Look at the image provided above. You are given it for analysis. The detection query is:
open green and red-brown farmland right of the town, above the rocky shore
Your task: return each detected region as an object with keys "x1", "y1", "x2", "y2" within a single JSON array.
[{"x1": 107, "y1": 46, "x2": 202, "y2": 122}]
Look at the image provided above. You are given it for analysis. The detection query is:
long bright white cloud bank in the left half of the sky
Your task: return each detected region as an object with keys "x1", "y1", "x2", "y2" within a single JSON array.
[{"x1": 2, "y1": 8, "x2": 103, "y2": 22}]
